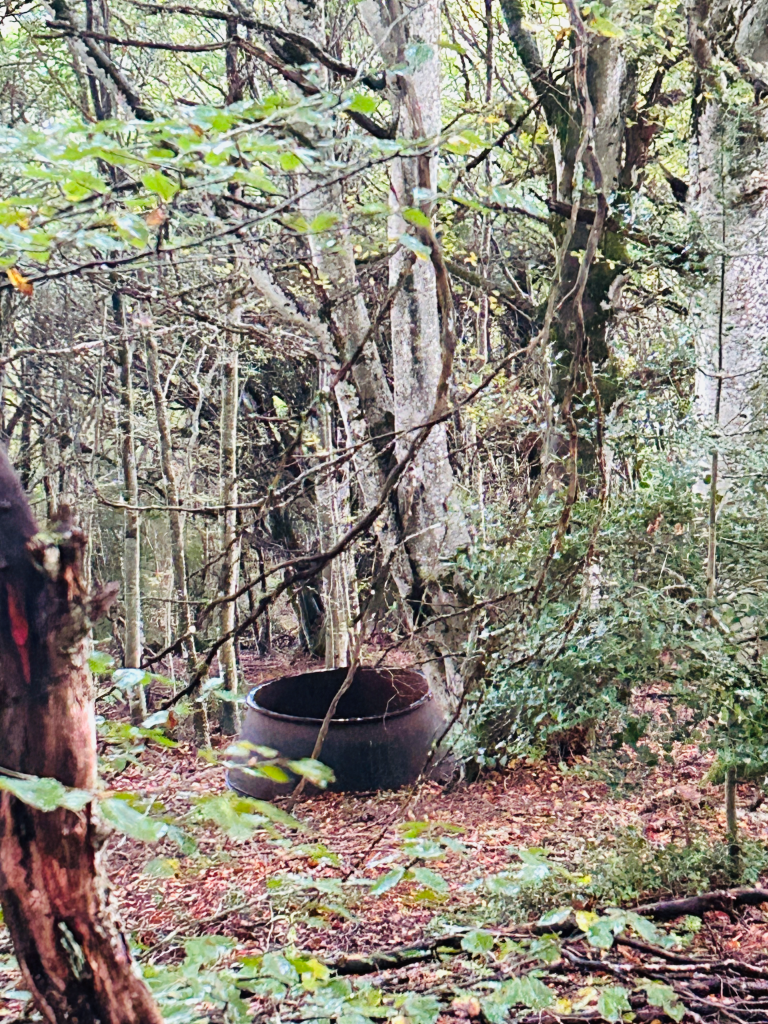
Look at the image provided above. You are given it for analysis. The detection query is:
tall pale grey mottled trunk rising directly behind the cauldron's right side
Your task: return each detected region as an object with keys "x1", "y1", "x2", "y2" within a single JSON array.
[{"x1": 358, "y1": 0, "x2": 469, "y2": 711}]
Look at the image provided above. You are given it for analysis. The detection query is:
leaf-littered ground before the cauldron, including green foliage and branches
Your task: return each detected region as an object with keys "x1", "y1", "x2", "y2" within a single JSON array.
[{"x1": 0, "y1": 667, "x2": 768, "y2": 1024}]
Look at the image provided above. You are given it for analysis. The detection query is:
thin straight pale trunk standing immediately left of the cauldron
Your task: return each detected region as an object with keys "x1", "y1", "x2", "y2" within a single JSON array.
[{"x1": 218, "y1": 339, "x2": 240, "y2": 736}]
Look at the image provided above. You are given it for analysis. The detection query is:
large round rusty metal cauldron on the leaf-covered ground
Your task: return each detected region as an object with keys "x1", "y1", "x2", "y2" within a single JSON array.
[{"x1": 227, "y1": 669, "x2": 443, "y2": 800}]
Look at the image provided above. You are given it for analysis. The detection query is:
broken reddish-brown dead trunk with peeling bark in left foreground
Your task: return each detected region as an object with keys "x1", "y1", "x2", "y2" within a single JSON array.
[{"x1": 0, "y1": 452, "x2": 162, "y2": 1024}]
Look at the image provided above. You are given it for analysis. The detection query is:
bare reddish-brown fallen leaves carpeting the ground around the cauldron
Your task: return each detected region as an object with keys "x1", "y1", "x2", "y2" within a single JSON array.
[{"x1": 0, "y1": 659, "x2": 768, "y2": 1024}]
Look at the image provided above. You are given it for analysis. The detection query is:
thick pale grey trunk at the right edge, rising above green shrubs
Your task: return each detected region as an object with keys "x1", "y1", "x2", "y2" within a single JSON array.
[{"x1": 689, "y1": 0, "x2": 768, "y2": 440}]
